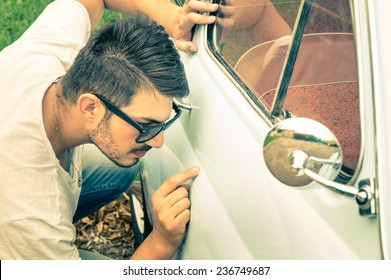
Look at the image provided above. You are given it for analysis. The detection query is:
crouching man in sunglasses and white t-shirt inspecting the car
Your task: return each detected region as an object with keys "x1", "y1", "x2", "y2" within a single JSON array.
[{"x1": 0, "y1": 0, "x2": 217, "y2": 259}]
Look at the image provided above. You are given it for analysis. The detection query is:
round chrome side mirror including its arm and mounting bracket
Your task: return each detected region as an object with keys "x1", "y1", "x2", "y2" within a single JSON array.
[{"x1": 263, "y1": 118, "x2": 376, "y2": 215}]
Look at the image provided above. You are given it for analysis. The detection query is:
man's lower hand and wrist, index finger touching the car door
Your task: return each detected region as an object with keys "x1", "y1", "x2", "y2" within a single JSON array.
[{"x1": 132, "y1": 167, "x2": 200, "y2": 260}]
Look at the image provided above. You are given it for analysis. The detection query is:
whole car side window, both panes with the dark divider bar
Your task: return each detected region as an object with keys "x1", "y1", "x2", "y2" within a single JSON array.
[{"x1": 207, "y1": 0, "x2": 361, "y2": 180}]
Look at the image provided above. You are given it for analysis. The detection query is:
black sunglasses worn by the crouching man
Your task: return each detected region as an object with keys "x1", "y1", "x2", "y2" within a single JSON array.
[{"x1": 94, "y1": 94, "x2": 182, "y2": 143}]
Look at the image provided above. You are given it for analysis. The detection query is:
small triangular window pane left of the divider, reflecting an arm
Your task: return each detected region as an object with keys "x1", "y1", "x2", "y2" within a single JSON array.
[{"x1": 214, "y1": 0, "x2": 300, "y2": 109}]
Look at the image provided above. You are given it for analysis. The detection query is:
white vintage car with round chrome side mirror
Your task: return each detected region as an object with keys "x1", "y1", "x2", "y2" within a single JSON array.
[{"x1": 133, "y1": 0, "x2": 391, "y2": 260}]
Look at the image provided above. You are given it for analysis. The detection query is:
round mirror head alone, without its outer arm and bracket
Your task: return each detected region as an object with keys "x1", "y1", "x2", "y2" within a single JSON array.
[{"x1": 263, "y1": 118, "x2": 342, "y2": 187}]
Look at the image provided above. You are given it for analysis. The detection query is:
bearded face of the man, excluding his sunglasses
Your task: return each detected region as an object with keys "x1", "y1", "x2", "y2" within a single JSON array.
[{"x1": 89, "y1": 92, "x2": 173, "y2": 167}]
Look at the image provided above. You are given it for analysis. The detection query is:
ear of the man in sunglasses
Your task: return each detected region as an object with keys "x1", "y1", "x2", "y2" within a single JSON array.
[{"x1": 77, "y1": 93, "x2": 106, "y2": 129}]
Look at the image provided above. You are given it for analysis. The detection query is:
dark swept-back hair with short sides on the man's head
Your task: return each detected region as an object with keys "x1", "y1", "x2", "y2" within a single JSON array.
[{"x1": 62, "y1": 13, "x2": 189, "y2": 106}]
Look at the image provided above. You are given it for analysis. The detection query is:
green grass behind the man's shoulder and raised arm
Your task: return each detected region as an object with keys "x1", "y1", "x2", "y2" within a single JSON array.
[{"x1": 0, "y1": 0, "x2": 119, "y2": 51}]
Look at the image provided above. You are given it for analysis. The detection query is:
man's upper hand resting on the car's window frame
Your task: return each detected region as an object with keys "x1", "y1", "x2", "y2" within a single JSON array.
[{"x1": 171, "y1": 0, "x2": 218, "y2": 52}]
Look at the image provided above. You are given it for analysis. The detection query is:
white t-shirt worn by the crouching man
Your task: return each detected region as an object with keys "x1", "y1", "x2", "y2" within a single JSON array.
[{"x1": 0, "y1": 0, "x2": 91, "y2": 259}]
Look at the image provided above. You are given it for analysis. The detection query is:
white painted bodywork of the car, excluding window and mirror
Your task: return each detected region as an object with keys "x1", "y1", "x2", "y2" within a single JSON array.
[{"x1": 141, "y1": 1, "x2": 390, "y2": 259}]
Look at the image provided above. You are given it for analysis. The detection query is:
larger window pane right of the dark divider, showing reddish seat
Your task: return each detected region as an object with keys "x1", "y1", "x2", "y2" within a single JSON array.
[{"x1": 282, "y1": 0, "x2": 361, "y2": 174}]
